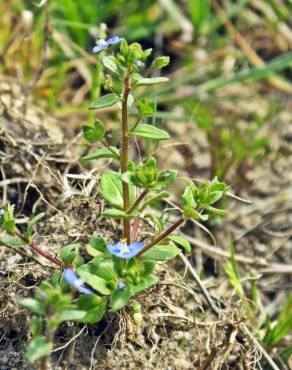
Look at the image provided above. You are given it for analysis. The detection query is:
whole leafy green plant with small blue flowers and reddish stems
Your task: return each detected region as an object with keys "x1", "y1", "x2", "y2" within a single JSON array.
[{"x1": 1, "y1": 36, "x2": 228, "y2": 369}]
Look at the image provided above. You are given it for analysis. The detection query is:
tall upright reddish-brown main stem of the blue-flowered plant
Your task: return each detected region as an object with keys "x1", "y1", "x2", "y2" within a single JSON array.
[{"x1": 120, "y1": 76, "x2": 131, "y2": 242}]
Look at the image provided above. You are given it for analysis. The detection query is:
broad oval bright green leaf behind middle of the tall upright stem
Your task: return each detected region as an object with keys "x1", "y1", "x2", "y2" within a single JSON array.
[{"x1": 100, "y1": 170, "x2": 136, "y2": 209}]
